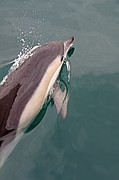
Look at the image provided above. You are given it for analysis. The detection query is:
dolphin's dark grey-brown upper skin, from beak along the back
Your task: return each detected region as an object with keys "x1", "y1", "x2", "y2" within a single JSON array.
[{"x1": 0, "y1": 37, "x2": 74, "y2": 149}]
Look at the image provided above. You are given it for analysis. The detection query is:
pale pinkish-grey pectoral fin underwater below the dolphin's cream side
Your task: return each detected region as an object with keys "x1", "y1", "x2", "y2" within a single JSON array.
[{"x1": 52, "y1": 83, "x2": 69, "y2": 119}]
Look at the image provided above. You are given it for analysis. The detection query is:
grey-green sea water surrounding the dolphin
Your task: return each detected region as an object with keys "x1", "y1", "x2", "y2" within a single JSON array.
[{"x1": 0, "y1": 0, "x2": 119, "y2": 180}]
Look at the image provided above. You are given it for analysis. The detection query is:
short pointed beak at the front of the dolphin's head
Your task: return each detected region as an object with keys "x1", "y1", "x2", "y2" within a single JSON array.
[{"x1": 64, "y1": 37, "x2": 74, "y2": 58}]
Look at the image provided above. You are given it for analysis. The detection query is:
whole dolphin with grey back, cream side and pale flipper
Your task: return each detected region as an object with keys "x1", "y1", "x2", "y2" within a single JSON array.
[{"x1": 0, "y1": 37, "x2": 74, "y2": 167}]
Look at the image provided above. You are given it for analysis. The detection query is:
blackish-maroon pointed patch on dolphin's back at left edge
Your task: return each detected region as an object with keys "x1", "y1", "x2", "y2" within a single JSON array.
[{"x1": 0, "y1": 84, "x2": 21, "y2": 138}]
